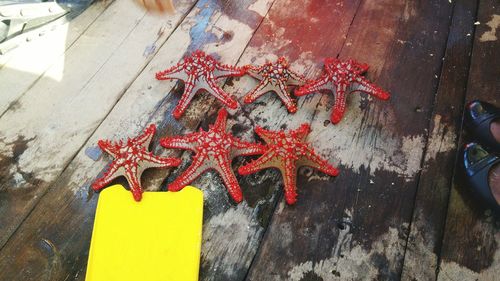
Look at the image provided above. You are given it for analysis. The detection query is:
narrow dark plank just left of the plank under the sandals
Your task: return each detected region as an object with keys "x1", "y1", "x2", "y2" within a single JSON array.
[{"x1": 401, "y1": 0, "x2": 477, "y2": 281}]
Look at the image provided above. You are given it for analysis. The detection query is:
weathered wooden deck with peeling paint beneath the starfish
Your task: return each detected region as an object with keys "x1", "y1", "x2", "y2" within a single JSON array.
[{"x1": 0, "y1": 0, "x2": 500, "y2": 281}]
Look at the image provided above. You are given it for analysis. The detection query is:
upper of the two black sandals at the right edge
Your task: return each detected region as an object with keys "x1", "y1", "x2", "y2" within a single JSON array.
[{"x1": 465, "y1": 100, "x2": 500, "y2": 152}]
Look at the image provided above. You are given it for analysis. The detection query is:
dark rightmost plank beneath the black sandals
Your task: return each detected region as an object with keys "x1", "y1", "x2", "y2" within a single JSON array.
[{"x1": 438, "y1": 0, "x2": 500, "y2": 281}]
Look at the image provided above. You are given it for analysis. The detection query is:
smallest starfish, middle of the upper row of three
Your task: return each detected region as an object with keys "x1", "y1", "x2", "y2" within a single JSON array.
[{"x1": 244, "y1": 57, "x2": 307, "y2": 113}]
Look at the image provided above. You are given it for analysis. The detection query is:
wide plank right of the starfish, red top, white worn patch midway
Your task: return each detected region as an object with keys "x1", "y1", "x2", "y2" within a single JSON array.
[{"x1": 247, "y1": 0, "x2": 458, "y2": 280}]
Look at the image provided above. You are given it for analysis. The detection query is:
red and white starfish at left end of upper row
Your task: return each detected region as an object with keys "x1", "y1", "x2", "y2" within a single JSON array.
[{"x1": 156, "y1": 50, "x2": 245, "y2": 119}]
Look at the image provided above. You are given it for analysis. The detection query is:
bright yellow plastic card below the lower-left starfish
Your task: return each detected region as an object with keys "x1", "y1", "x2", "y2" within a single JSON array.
[{"x1": 85, "y1": 185, "x2": 203, "y2": 281}]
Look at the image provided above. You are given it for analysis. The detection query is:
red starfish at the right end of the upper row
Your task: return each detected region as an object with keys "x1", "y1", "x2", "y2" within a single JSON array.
[{"x1": 295, "y1": 58, "x2": 390, "y2": 124}]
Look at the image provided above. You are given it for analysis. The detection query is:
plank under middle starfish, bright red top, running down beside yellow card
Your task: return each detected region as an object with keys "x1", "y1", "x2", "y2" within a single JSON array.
[{"x1": 186, "y1": 1, "x2": 366, "y2": 280}]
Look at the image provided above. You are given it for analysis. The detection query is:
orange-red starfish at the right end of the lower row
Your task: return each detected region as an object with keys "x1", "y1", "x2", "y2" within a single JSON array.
[{"x1": 238, "y1": 124, "x2": 339, "y2": 205}]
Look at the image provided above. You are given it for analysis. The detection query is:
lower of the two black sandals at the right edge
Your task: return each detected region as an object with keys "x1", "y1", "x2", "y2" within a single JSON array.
[{"x1": 464, "y1": 143, "x2": 500, "y2": 208}]
